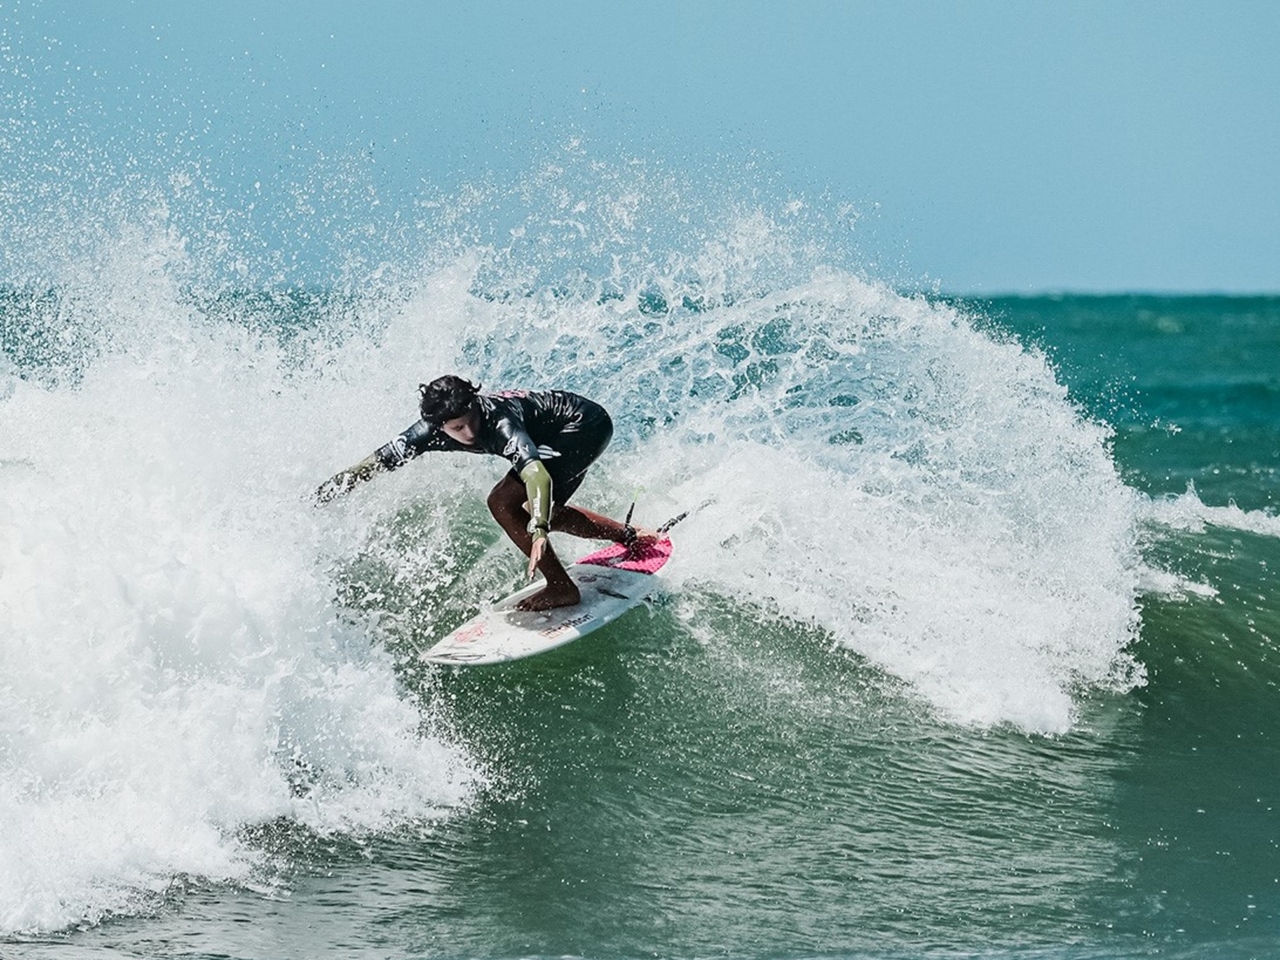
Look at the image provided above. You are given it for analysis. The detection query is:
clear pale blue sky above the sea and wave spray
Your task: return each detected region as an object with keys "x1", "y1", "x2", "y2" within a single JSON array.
[{"x1": 0, "y1": 0, "x2": 1280, "y2": 293}]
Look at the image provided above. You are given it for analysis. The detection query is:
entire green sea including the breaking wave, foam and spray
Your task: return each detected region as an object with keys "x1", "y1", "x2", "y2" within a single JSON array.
[{"x1": 0, "y1": 159, "x2": 1280, "y2": 959}]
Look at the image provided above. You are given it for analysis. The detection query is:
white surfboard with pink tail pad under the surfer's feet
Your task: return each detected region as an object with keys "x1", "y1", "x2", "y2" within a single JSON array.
[{"x1": 422, "y1": 538, "x2": 671, "y2": 666}]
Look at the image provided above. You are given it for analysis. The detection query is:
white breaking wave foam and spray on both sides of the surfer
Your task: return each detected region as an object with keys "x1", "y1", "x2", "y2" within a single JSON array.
[{"x1": 0, "y1": 151, "x2": 1146, "y2": 933}]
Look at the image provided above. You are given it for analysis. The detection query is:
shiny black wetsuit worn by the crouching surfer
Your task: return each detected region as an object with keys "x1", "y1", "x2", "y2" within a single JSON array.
[{"x1": 376, "y1": 390, "x2": 613, "y2": 503}]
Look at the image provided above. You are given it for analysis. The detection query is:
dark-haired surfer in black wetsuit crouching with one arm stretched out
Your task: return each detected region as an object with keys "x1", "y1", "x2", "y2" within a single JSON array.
[{"x1": 316, "y1": 374, "x2": 657, "y2": 611}]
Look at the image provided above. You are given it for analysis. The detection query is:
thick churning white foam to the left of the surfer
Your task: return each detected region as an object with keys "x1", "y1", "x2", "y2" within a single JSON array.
[{"x1": 0, "y1": 224, "x2": 479, "y2": 932}]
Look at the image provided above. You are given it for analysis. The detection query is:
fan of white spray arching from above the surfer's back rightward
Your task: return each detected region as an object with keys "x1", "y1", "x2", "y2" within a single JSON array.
[{"x1": 373, "y1": 235, "x2": 1142, "y2": 732}]
